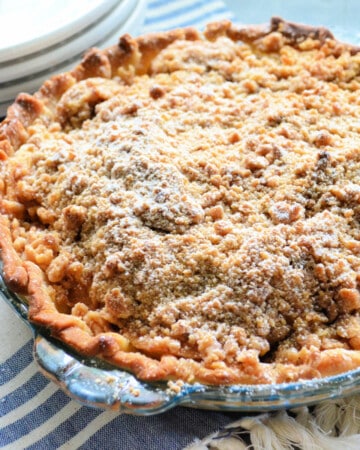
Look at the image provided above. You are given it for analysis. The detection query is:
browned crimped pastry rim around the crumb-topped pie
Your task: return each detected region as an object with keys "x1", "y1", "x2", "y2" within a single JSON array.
[{"x1": 0, "y1": 17, "x2": 360, "y2": 384}]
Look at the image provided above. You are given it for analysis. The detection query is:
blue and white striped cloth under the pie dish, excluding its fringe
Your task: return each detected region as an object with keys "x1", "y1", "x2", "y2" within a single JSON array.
[{"x1": 0, "y1": 0, "x2": 237, "y2": 450}]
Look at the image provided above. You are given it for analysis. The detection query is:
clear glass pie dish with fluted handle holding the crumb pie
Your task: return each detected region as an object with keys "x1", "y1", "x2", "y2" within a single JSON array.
[{"x1": 0, "y1": 270, "x2": 360, "y2": 416}]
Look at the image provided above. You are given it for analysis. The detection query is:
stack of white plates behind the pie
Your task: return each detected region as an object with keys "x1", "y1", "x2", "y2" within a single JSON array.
[{"x1": 0, "y1": 0, "x2": 146, "y2": 117}]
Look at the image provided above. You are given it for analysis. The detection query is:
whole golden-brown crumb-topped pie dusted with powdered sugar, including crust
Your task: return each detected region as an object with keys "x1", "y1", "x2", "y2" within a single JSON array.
[{"x1": 0, "y1": 18, "x2": 360, "y2": 384}]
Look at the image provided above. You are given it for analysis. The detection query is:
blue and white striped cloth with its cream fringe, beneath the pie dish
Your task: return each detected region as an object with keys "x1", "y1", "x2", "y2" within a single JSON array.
[{"x1": 0, "y1": 0, "x2": 360, "y2": 450}]
